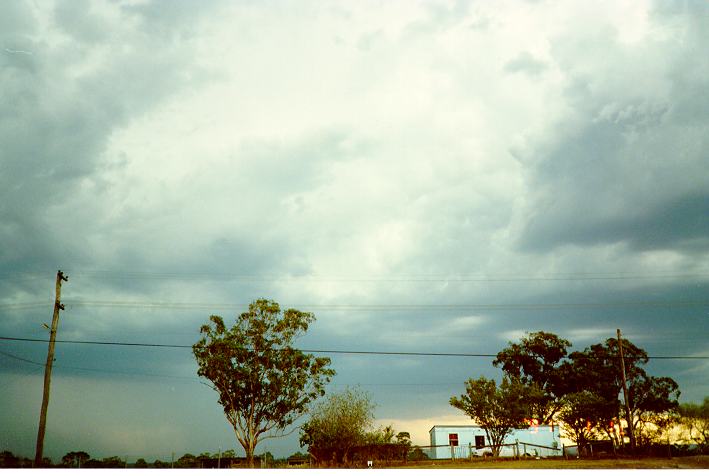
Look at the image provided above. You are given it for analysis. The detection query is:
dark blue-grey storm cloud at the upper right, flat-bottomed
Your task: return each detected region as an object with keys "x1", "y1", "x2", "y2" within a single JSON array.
[{"x1": 520, "y1": 3, "x2": 709, "y2": 253}]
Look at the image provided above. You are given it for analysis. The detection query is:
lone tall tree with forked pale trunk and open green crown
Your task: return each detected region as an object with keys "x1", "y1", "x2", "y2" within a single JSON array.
[{"x1": 192, "y1": 299, "x2": 335, "y2": 467}]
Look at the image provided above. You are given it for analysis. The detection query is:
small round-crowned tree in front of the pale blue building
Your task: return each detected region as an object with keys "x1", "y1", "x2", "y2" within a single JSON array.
[{"x1": 450, "y1": 377, "x2": 530, "y2": 457}]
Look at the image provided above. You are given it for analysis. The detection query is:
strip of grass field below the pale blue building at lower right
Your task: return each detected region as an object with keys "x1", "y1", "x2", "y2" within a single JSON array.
[{"x1": 392, "y1": 456, "x2": 709, "y2": 469}]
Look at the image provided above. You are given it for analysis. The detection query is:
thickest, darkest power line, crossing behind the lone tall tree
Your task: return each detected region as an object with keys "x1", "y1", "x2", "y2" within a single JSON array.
[{"x1": 0, "y1": 336, "x2": 709, "y2": 360}]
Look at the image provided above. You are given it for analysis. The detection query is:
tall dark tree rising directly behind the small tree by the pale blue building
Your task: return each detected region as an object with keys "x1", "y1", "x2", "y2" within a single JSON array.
[{"x1": 492, "y1": 331, "x2": 571, "y2": 424}]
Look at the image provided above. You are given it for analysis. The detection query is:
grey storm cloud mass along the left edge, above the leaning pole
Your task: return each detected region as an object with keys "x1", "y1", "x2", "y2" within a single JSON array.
[{"x1": 0, "y1": 2, "x2": 221, "y2": 282}]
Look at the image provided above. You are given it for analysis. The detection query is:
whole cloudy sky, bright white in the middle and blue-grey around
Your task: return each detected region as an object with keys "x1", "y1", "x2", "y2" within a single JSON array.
[{"x1": 0, "y1": 0, "x2": 709, "y2": 461}]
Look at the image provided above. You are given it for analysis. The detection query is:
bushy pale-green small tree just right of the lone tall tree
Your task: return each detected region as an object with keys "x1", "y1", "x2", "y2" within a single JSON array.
[{"x1": 300, "y1": 388, "x2": 374, "y2": 465}]
